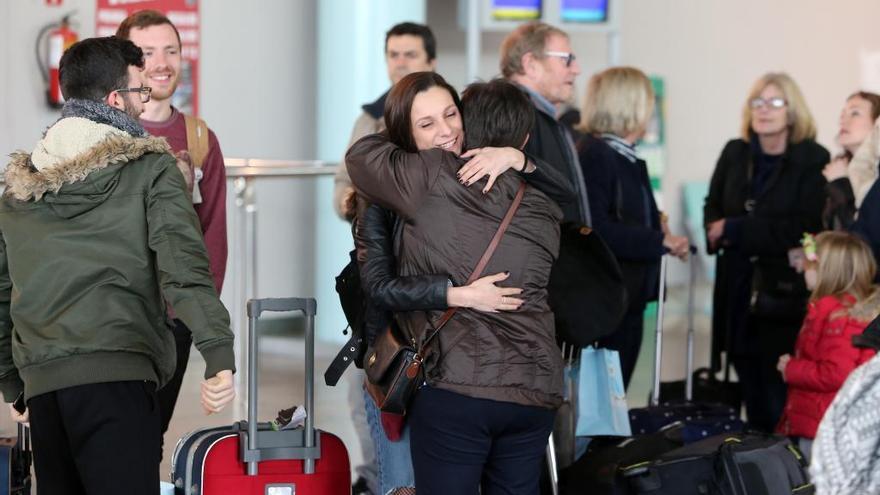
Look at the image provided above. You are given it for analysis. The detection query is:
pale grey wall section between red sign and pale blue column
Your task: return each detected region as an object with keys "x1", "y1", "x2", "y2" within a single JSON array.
[{"x1": 200, "y1": 0, "x2": 318, "y2": 160}]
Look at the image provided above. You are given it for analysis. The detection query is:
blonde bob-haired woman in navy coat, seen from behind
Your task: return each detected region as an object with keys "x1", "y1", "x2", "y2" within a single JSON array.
[{"x1": 578, "y1": 67, "x2": 689, "y2": 385}]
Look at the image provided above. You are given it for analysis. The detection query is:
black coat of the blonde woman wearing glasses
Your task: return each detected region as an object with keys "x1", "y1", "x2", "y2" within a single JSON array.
[{"x1": 704, "y1": 139, "x2": 830, "y2": 368}]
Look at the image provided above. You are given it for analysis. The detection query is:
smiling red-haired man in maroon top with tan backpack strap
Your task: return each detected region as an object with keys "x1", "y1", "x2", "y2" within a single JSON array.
[{"x1": 116, "y1": 10, "x2": 227, "y2": 446}]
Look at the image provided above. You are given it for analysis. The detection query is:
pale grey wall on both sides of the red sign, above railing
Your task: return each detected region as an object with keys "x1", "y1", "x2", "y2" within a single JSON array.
[{"x1": 0, "y1": 0, "x2": 317, "y2": 159}]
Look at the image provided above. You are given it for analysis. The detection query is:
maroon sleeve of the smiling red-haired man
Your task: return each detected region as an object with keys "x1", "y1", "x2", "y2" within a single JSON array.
[{"x1": 195, "y1": 130, "x2": 228, "y2": 294}]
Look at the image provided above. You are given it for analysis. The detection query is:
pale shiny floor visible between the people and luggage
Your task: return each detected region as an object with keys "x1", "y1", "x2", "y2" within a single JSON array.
[{"x1": 0, "y1": 285, "x2": 711, "y2": 481}]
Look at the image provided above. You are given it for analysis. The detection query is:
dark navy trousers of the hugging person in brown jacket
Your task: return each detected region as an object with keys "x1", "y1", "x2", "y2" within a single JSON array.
[{"x1": 407, "y1": 386, "x2": 556, "y2": 495}]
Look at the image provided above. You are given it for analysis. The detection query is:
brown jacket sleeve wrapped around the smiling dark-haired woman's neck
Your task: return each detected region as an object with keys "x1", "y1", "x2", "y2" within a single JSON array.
[{"x1": 345, "y1": 134, "x2": 446, "y2": 218}]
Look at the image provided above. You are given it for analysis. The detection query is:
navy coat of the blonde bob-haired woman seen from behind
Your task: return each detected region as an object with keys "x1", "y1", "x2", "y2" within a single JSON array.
[{"x1": 577, "y1": 131, "x2": 666, "y2": 312}]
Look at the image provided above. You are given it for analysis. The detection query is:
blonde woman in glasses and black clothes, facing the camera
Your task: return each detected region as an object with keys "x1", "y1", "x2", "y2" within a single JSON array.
[{"x1": 704, "y1": 72, "x2": 830, "y2": 432}]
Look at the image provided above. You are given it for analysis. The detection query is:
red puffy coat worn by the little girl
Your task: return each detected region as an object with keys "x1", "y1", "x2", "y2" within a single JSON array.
[{"x1": 776, "y1": 295, "x2": 874, "y2": 438}]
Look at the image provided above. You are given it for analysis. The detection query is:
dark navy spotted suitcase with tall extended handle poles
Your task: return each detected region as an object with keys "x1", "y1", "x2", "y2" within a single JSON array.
[{"x1": 630, "y1": 255, "x2": 745, "y2": 443}]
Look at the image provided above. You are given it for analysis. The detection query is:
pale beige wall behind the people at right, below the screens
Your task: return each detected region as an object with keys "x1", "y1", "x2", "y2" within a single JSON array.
[{"x1": 428, "y1": 0, "x2": 880, "y2": 270}]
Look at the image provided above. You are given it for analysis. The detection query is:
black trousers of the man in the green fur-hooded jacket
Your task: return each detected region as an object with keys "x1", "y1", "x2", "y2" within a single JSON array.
[{"x1": 27, "y1": 381, "x2": 159, "y2": 495}]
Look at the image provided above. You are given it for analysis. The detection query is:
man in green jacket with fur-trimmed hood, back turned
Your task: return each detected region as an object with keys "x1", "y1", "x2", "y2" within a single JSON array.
[{"x1": 0, "y1": 38, "x2": 235, "y2": 495}]
